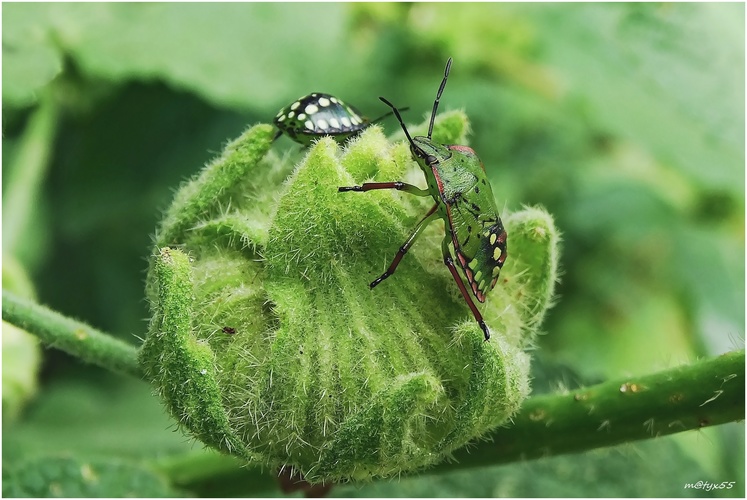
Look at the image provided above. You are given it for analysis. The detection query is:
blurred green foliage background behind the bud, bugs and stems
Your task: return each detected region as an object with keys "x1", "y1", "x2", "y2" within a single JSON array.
[{"x1": 2, "y1": 3, "x2": 745, "y2": 496}]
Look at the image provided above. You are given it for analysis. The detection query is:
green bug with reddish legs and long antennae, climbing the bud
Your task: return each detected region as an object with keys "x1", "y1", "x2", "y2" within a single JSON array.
[{"x1": 338, "y1": 58, "x2": 507, "y2": 341}]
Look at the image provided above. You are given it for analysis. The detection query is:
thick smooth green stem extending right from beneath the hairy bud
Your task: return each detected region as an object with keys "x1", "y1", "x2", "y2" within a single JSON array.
[{"x1": 436, "y1": 350, "x2": 745, "y2": 473}]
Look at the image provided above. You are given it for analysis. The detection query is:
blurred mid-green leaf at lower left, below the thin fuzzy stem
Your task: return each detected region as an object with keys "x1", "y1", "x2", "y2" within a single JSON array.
[{"x1": 2, "y1": 376, "x2": 193, "y2": 464}]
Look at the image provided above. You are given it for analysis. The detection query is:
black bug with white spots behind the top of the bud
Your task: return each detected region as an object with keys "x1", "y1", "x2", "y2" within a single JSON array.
[{"x1": 273, "y1": 92, "x2": 406, "y2": 146}]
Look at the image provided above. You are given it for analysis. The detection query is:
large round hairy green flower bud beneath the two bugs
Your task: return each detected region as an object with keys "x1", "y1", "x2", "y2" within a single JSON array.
[{"x1": 140, "y1": 112, "x2": 558, "y2": 483}]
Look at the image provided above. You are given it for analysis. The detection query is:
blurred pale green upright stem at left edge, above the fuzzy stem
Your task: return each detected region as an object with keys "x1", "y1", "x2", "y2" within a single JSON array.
[{"x1": 3, "y1": 94, "x2": 59, "y2": 255}]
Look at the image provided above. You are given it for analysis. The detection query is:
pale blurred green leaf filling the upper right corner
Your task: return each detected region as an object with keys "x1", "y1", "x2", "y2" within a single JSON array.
[{"x1": 532, "y1": 3, "x2": 745, "y2": 193}]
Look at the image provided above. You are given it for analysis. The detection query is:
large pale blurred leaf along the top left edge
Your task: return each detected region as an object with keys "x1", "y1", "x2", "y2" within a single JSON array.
[{"x1": 3, "y1": 3, "x2": 345, "y2": 107}]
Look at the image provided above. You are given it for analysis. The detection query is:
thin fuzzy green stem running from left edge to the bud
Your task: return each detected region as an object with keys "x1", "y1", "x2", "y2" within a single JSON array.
[{"x1": 3, "y1": 290, "x2": 142, "y2": 378}]
